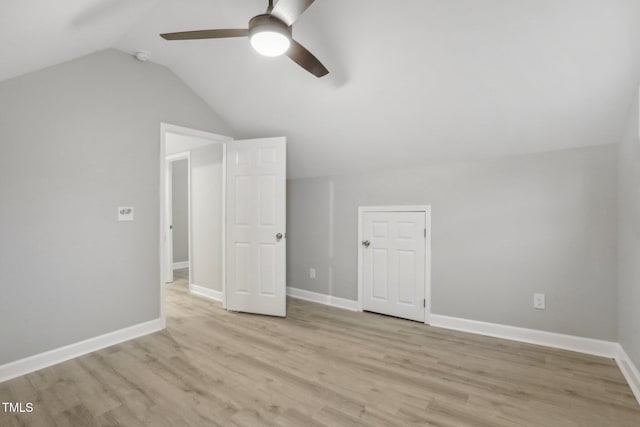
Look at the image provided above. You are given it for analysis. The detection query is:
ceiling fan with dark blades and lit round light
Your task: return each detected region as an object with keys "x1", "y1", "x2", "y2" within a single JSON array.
[{"x1": 160, "y1": 0, "x2": 329, "y2": 77}]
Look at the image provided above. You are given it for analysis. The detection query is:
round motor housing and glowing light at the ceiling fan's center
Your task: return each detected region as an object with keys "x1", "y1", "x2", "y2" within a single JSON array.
[{"x1": 249, "y1": 15, "x2": 291, "y2": 57}]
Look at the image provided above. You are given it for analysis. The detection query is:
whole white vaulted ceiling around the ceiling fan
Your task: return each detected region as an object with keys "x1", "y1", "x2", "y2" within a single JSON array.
[{"x1": 0, "y1": 0, "x2": 640, "y2": 177}]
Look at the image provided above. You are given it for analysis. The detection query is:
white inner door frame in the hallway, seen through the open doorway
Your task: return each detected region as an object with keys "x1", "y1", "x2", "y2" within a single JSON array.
[{"x1": 163, "y1": 151, "x2": 191, "y2": 283}]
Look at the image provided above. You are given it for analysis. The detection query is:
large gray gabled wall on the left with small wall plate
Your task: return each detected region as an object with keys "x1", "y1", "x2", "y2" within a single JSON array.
[{"x1": 0, "y1": 50, "x2": 232, "y2": 364}]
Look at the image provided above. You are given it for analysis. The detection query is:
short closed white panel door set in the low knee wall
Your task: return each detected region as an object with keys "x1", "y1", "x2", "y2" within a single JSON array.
[{"x1": 362, "y1": 212, "x2": 426, "y2": 322}]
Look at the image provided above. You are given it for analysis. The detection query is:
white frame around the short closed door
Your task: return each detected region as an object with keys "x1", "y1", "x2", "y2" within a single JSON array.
[{"x1": 357, "y1": 205, "x2": 431, "y2": 324}]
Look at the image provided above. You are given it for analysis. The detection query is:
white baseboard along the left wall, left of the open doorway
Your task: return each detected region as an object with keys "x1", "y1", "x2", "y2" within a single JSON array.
[{"x1": 0, "y1": 319, "x2": 165, "y2": 383}]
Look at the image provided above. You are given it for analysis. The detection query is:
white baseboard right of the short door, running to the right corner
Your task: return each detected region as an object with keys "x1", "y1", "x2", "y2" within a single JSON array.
[{"x1": 429, "y1": 314, "x2": 619, "y2": 359}]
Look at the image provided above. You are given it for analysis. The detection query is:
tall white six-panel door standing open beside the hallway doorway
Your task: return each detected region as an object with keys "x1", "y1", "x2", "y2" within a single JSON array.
[{"x1": 225, "y1": 138, "x2": 287, "y2": 316}]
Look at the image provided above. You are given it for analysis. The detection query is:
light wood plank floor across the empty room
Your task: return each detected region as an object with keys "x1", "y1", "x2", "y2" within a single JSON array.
[{"x1": 0, "y1": 274, "x2": 640, "y2": 427}]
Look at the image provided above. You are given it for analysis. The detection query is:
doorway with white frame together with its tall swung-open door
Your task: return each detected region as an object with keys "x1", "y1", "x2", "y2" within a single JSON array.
[{"x1": 159, "y1": 123, "x2": 286, "y2": 324}]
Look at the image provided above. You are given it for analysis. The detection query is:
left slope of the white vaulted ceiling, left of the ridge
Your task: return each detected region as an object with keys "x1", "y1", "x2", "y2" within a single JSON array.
[{"x1": 0, "y1": 0, "x2": 158, "y2": 81}]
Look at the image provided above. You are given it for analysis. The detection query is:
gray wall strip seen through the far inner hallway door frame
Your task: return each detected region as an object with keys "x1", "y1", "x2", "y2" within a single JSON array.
[{"x1": 171, "y1": 159, "x2": 189, "y2": 262}]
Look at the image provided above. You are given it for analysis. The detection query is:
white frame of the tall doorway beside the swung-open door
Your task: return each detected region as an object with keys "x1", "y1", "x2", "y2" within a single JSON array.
[{"x1": 158, "y1": 123, "x2": 233, "y2": 327}]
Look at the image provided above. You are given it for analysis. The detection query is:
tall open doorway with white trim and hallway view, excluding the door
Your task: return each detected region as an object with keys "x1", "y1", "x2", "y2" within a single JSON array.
[{"x1": 160, "y1": 123, "x2": 231, "y2": 319}]
